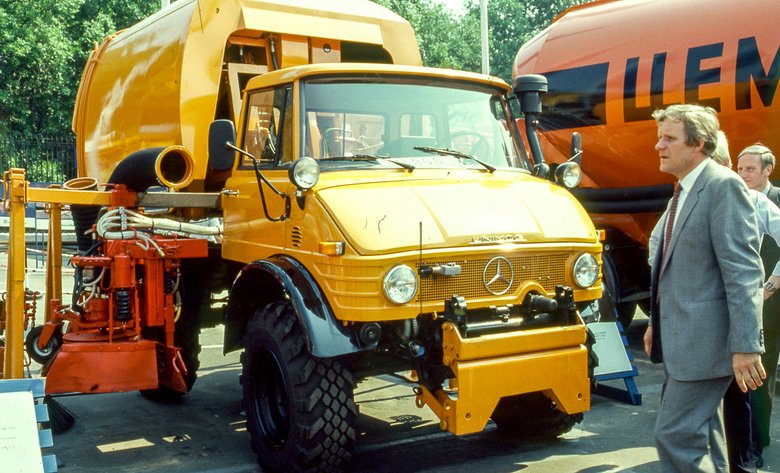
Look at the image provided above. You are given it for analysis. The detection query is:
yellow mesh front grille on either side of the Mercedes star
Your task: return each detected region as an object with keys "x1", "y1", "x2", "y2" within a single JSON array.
[{"x1": 416, "y1": 253, "x2": 569, "y2": 302}]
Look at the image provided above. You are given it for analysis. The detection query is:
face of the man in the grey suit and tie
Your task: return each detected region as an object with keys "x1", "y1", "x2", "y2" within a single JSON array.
[{"x1": 655, "y1": 120, "x2": 706, "y2": 179}]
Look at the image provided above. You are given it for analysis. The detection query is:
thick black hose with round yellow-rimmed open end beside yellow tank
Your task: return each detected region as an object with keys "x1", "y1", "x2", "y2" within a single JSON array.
[{"x1": 108, "y1": 145, "x2": 194, "y2": 192}]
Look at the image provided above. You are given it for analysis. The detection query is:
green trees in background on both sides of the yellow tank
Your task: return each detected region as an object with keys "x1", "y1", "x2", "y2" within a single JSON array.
[{"x1": 0, "y1": 0, "x2": 583, "y2": 134}]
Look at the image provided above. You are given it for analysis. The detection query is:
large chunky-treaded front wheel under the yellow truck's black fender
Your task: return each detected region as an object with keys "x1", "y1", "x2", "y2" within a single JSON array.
[{"x1": 241, "y1": 301, "x2": 357, "y2": 472}]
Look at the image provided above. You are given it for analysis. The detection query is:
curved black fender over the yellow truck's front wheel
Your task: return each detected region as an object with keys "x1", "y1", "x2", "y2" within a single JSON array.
[{"x1": 224, "y1": 255, "x2": 362, "y2": 358}]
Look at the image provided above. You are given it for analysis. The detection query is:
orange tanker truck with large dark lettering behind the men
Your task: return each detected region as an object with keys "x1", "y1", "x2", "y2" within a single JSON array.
[{"x1": 513, "y1": 0, "x2": 780, "y2": 324}]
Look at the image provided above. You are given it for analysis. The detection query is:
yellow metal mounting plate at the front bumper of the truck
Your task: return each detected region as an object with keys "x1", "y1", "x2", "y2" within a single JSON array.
[{"x1": 416, "y1": 322, "x2": 590, "y2": 435}]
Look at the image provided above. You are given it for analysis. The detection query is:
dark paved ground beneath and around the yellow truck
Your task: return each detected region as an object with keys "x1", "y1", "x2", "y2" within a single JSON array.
[{"x1": 0, "y1": 248, "x2": 780, "y2": 473}]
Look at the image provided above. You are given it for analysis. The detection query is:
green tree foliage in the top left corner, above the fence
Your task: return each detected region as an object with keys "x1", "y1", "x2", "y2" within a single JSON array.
[{"x1": 0, "y1": 0, "x2": 160, "y2": 134}]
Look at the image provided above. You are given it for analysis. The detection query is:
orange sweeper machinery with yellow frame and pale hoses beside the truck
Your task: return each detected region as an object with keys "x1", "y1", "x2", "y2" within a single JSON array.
[{"x1": 4, "y1": 169, "x2": 210, "y2": 396}]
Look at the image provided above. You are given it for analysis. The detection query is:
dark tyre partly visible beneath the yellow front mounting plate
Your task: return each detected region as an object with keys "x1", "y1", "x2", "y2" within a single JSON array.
[{"x1": 491, "y1": 393, "x2": 582, "y2": 440}]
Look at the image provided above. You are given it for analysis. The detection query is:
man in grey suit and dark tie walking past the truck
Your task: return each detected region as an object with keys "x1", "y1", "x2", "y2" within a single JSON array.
[{"x1": 644, "y1": 105, "x2": 766, "y2": 472}]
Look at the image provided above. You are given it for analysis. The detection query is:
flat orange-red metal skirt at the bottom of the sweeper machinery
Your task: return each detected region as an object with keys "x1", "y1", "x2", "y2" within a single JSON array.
[{"x1": 45, "y1": 340, "x2": 158, "y2": 394}]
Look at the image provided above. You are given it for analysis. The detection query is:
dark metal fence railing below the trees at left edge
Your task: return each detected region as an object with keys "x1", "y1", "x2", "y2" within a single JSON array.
[{"x1": 0, "y1": 133, "x2": 77, "y2": 183}]
